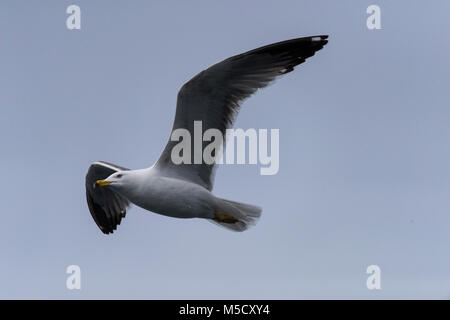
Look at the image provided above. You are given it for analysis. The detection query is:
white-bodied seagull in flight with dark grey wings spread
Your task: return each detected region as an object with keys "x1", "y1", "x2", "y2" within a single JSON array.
[{"x1": 86, "y1": 35, "x2": 328, "y2": 234}]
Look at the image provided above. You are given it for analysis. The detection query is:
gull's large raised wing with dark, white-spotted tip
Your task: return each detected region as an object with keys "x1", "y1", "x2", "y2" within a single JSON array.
[{"x1": 155, "y1": 35, "x2": 328, "y2": 190}]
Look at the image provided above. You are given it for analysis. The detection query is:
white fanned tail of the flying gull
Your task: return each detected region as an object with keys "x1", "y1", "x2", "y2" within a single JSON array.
[{"x1": 210, "y1": 198, "x2": 262, "y2": 231}]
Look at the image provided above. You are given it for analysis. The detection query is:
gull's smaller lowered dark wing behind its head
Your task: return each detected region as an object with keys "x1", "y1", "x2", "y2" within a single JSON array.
[{"x1": 86, "y1": 161, "x2": 130, "y2": 234}]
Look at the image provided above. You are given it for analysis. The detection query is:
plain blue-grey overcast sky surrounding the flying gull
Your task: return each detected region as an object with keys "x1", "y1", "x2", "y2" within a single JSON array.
[{"x1": 0, "y1": 0, "x2": 450, "y2": 299}]
